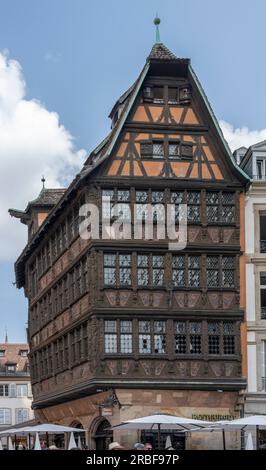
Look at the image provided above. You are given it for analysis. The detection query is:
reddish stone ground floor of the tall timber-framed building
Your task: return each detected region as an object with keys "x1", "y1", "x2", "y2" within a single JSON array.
[{"x1": 35, "y1": 389, "x2": 243, "y2": 449}]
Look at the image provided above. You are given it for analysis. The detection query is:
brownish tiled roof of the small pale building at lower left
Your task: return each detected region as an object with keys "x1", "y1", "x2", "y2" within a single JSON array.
[{"x1": 0, "y1": 343, "x2": 29, "y2": 375}]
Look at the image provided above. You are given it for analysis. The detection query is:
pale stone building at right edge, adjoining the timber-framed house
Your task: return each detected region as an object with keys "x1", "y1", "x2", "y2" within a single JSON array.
[{"x1": 238, "y1": 141, "x2": 266, "y2": 426}]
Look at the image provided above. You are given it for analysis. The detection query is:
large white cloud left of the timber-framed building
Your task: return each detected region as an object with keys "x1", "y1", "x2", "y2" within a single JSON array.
[{"x1": 0, "y1": 52, "x2": 85, "y2": 260}]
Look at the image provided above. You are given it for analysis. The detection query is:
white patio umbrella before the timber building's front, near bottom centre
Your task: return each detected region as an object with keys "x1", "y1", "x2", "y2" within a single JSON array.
[{"x1": 112, "y1": 414, "x2": 212, "y2": 448}]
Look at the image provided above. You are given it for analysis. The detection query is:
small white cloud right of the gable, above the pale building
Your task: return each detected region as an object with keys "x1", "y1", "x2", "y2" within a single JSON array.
[{"x1": 220, "y1": 121, "x2": 266, "y2": 151}]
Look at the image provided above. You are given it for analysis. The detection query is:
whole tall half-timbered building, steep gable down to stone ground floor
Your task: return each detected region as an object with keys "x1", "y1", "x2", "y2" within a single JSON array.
[{"x1": 11, "y1": 35, "x2": 248, "y2": 449}]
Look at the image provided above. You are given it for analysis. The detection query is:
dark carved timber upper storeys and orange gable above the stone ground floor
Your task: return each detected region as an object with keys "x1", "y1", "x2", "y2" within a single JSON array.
[{"x1": 12, "y1": 44, "x2": 248, "y2": 408}]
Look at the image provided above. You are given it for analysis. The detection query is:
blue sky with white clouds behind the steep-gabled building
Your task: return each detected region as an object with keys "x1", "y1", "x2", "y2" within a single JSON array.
[{"x1": 0, "y1": 0, "x2": 266, "y2": 342}]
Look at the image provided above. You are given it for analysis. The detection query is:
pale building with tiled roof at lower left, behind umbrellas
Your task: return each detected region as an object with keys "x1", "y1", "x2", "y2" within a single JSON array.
[{"x1": 0, "y1": 342, "x2": 34, "y2": 429}]
